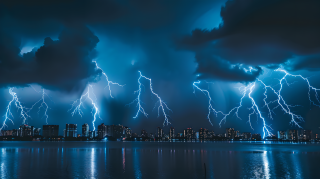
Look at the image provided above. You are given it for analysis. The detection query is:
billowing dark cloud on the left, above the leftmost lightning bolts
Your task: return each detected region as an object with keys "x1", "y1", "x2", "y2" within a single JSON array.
[{"x1": 0, "y1": 26, "x2": 101, "y2": 91}]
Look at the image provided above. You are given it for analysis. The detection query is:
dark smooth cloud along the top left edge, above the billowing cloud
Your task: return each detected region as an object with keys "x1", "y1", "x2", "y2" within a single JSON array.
[{"x1": 0, "y1": 0, "x2": 126, "y2": 39}]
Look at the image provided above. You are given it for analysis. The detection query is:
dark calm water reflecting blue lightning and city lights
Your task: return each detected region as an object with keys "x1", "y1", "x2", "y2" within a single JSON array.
[{"x1": 0, "y1": 141, "x2": 320, "y2": 179}]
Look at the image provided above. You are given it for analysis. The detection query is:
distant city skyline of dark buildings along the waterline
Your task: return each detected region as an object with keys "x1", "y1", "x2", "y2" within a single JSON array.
[{"x1": 0, "y1": 123, "x2": 319, "y2": 141}]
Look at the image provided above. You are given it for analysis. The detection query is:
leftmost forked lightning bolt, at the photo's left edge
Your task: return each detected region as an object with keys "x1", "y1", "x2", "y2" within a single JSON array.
[{"x1": 0, "y1": 88, "x2": 30, "y2": 131}]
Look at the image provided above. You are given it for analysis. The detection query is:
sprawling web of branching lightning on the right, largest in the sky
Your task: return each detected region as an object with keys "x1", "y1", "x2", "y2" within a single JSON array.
[{"x1": 193, "y1": 69, "x2": 320, "y2": 138}]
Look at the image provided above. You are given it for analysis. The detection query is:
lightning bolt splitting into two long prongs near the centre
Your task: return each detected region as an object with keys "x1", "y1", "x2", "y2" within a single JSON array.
[{"x1": 129, "y1": 71, "x2": 172, "y2": 126}]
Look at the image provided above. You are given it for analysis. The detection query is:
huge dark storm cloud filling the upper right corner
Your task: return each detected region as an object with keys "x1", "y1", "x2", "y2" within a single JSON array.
[{"x1": 178, "y1": 0, "x2": 320, "y2": 77}]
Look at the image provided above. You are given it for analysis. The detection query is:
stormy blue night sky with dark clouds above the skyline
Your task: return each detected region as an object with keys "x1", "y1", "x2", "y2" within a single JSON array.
[{"x1": 0, "y1": 0, "x2": 320, "y2": 134}]
